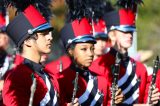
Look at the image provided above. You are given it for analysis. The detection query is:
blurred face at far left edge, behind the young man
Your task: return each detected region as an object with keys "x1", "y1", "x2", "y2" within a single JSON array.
[{"x1": 0, "y1": 33, "x2": 9, "y2": 50}]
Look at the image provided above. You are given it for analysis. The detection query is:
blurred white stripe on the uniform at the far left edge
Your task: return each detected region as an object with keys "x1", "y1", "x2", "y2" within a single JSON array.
[{"x1": 0, "y1": 56, "x2": 9, "y2": 78}]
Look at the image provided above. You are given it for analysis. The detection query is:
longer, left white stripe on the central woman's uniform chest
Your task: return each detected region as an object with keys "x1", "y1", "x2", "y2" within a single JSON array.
[{"x1": 79, "y1": 75, "x2": 94, "y2": 104}]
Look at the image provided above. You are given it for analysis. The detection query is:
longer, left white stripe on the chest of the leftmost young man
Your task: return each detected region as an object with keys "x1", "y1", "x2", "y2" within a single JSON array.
[{"x1": 40, "y1": 75, "x2": 51, "y2": 106}]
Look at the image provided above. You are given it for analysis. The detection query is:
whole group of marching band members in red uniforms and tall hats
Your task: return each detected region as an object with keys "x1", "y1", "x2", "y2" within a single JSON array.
[{"x1": 0, "y1": 0, "x2": 160, "y2": 106}]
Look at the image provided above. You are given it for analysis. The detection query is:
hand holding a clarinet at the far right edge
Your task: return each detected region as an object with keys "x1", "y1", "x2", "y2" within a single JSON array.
[{"x1": 151, "y1": 88, "x2": 160, "y2": 105}]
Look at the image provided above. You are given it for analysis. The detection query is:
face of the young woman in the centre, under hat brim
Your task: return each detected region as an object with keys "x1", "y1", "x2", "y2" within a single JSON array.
[{"x1": 69, "y1": 43, "x2": 94, "y2": 68}]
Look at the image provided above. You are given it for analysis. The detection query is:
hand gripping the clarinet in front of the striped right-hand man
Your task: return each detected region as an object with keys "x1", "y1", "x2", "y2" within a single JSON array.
[{"x1": 115, "y1": 89, "x2": 124, "y2": 104}]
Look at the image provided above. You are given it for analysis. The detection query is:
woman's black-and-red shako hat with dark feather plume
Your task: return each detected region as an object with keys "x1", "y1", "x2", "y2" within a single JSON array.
[{"x1": 61, "y1": 0, "x2": 96, "y2": 49}]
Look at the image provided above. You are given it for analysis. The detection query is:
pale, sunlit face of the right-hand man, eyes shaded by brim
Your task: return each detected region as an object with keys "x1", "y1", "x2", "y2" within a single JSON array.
[{"x1": 115, "y1": 31, "x2": 133, "y2": 49}]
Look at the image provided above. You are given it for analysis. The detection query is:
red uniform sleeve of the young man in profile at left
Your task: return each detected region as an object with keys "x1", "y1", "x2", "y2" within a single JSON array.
[{"x1": 2, "y1": 69, "x2": 31, "y2": 106}]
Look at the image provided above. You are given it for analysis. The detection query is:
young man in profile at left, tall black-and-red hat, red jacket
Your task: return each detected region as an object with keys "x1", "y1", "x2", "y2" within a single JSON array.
[{"x1": 2, "y1": 5, "x2": 58, "y2": 106}]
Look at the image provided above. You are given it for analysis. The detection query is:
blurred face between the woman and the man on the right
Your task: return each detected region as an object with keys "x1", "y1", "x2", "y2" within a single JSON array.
[{"x1": 94, "y1": 39, "x2": 106, "y2": 56}]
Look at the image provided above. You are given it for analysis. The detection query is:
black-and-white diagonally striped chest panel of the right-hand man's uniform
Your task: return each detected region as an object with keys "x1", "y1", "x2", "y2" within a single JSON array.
[{"x1": 118, "y1": 61, "x2": 139, "y2": 105}]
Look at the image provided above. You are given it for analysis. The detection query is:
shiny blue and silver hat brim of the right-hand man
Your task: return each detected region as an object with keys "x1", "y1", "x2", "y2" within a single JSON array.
[{"x1": 110, "y1": 25, "x2": 136, "y2": 32}]
